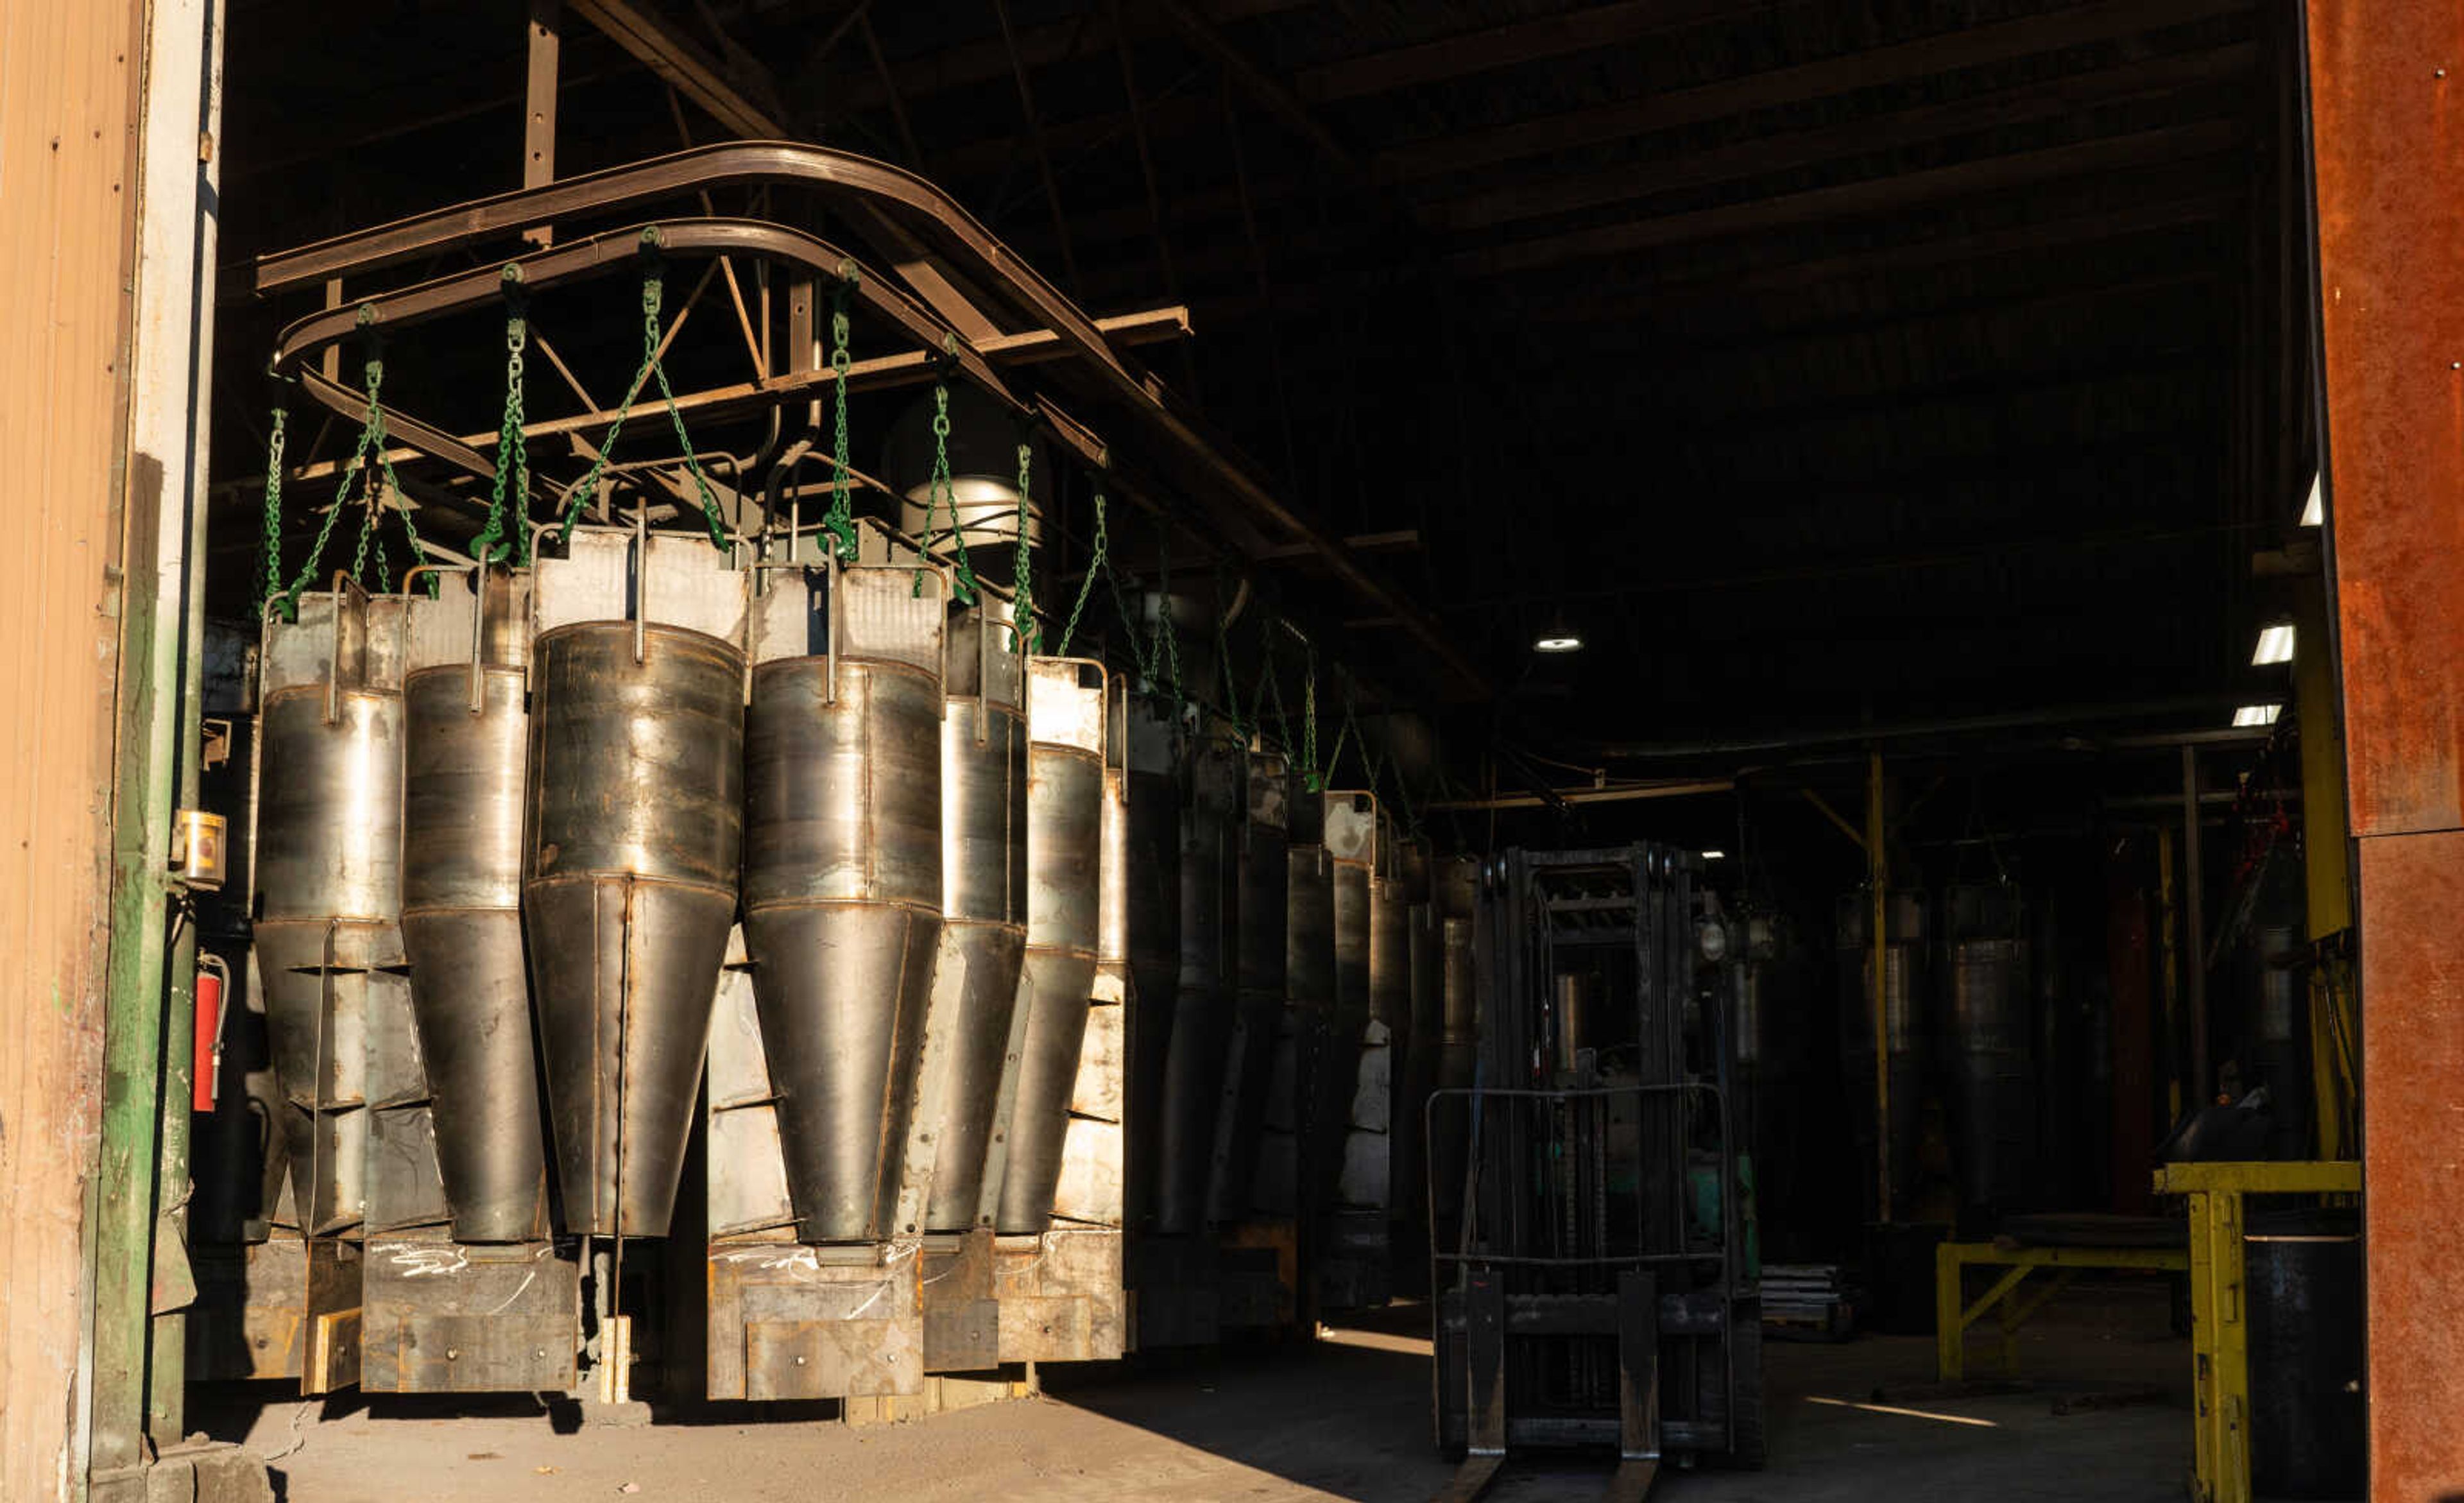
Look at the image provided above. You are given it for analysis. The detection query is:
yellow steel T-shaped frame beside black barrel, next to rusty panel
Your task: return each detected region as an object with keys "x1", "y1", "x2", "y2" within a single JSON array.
[{"x1": 2156, "y1": 1160, "x2": 2361, "y2": 1503}]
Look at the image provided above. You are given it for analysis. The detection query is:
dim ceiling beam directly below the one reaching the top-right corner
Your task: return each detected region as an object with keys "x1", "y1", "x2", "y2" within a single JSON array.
[{"x1": 1432, "y1": 42, "x2": 2259, "y2": 229}]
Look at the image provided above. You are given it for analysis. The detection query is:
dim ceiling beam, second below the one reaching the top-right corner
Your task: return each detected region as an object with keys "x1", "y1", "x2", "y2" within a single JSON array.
[{"x1": 1444, "y1": 121, "x2": 2245, "y2": 276}]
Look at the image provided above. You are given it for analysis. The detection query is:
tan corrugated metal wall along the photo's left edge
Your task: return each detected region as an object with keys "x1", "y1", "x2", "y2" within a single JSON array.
[{"x1": 0, "y1": 0, "x2": 143, "y2": 1503}]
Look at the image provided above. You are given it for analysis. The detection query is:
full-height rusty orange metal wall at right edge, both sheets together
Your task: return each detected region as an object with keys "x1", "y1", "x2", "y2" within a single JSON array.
[{"x1": 2309, "y1": 0, "x2": 2464, "y2": 1498}]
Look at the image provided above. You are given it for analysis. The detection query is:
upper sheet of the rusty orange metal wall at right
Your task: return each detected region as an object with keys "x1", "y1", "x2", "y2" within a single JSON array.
[{"x1": 2282, "y1": 0, "x2": 2464, "y2": 836}]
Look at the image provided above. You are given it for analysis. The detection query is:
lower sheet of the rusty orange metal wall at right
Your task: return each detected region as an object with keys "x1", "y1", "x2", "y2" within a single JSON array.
[{"x1": 2361, "y1": 830, "x2": 2464, "y2": 1498}]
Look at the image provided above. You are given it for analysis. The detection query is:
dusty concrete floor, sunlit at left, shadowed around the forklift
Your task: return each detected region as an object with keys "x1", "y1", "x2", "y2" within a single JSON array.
[{"x1": 200, "y1": 1284, "x2": 2191, "y2": 1503}]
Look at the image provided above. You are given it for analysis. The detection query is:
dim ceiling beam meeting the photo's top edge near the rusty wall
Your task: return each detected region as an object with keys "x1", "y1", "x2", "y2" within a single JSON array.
[{"x1": 1373, "y1": 0, "x2": 2250, "y2": 182}]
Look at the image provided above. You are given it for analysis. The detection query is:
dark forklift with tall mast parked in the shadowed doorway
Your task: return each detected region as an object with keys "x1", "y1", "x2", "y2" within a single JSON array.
[{"x1": 1429, "y1": 845, "x2": 1764, "y2": 1500}]
